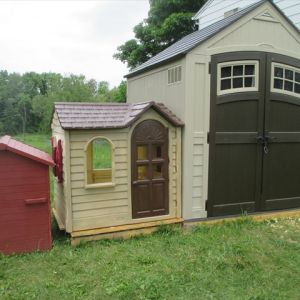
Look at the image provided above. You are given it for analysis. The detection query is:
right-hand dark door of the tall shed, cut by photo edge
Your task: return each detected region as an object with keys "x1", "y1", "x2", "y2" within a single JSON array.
[{"x1": 261, "y1": 54, "x2": 300, "y2": 210}]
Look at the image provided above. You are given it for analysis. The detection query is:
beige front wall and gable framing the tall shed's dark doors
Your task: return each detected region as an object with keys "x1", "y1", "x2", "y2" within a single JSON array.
[{"x1": 183, "y1": 3, "x2": 300, "y2": 218}]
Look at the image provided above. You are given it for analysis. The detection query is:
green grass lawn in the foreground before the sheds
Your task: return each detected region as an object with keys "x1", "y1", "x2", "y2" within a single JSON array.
[{"x1": 0, "y1": 135, "x2": 300, "y2": 300}]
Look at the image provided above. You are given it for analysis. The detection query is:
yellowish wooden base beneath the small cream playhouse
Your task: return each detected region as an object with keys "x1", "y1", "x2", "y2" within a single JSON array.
[{"x1": 71, "y1": 218, "x2": 183, "y2": 246}]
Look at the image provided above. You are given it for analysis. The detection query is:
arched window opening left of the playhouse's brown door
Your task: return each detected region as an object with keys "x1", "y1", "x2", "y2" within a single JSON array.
[{"x1": 87, "y1": 138, "x2": 113, "y2": 184}]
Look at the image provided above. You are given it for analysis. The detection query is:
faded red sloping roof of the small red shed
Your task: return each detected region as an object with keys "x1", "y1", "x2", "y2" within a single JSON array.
[{"x1": 0, "y1": 135, "x2": 55, "y2": 166}]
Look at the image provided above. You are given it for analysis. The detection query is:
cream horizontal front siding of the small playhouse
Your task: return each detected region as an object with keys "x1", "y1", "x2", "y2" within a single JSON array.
[{"x1": 70, "y1": 111, "x2": 181, "y2": 232}]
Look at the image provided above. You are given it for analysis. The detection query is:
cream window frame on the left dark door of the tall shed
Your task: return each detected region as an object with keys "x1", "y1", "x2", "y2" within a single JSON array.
[{"x1": 217, "y1": 60, "x2": 259, "y2": 96}]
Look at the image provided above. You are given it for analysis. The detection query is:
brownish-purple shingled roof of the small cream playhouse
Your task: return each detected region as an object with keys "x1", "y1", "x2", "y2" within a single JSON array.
[{"x1": 54, "y1": 101, "x2": 184, "y2": 129}]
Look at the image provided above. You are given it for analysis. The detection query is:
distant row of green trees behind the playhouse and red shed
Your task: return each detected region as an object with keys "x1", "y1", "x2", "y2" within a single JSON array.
[{"x1": 0, "y1": 71, "x2": 126, "y2": 135}]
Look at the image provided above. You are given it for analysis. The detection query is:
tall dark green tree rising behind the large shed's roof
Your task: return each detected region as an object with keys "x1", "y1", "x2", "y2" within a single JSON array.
[{"x1": 114, "y1": 0, "x2": 206, "y2": 69}]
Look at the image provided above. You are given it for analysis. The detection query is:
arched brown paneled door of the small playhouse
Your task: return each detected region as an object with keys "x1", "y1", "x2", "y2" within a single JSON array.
[{"x1": 131, "y1": 120, "x2": 169, "y2": 218}]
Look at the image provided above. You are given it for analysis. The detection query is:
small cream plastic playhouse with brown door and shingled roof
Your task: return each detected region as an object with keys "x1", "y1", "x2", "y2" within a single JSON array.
[{"x1": 52, "y1": 102, "x2": 183, "y2": 243}]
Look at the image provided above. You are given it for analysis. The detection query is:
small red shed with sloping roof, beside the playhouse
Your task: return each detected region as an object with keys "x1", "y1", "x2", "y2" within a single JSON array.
[{"x1": 0, "y1": 136, "x2": 54, "y2": 254}]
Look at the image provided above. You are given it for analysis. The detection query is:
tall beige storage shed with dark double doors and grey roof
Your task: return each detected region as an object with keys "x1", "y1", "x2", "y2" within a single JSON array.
[{"x1": 127, "y1": 0, "x2": 300, "y2": 220}]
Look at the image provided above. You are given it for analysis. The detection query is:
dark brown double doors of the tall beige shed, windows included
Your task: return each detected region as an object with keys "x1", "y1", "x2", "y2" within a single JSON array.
[{"x1": 207, "y1": 52, "x2": 300, "y2": 216}]
